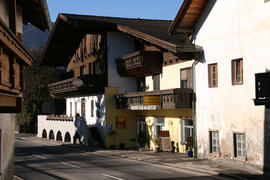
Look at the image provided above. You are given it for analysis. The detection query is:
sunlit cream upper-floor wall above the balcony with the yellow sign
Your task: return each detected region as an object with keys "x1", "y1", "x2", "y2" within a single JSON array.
[{"x1": 145, "y1": 60, "x2": 194, "y2": 91}]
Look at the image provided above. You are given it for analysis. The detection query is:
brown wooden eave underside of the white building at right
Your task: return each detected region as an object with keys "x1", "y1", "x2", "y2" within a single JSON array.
[{"x1": 169, "y1": 0, "x2": 208, "y2": 34}]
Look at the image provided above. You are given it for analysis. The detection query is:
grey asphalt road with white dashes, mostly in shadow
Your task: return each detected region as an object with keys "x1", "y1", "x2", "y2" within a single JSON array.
[{"x1": 14, "y1": 139, "x2": 234, "y2": 180}]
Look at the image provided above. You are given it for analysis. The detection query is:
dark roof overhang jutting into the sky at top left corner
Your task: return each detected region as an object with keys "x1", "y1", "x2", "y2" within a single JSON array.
[{"x1": 17, "y1": 0, "x2": 52, "y2": 31}]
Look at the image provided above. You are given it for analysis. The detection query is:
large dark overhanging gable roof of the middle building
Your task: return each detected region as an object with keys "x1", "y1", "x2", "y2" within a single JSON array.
[{"x1": 41, "y1": 14, "x2": 200, "y2": 66}]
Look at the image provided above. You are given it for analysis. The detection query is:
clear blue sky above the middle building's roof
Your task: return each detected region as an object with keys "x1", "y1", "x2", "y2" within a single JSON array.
[{"x1": 47, "y1": 0, "x2": 182, "y2": 22}]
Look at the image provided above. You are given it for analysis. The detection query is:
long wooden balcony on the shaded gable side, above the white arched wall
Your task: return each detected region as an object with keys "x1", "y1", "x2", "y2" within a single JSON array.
[{"x1": 48, "y1": 75, "x2": 106, "y2": 97}]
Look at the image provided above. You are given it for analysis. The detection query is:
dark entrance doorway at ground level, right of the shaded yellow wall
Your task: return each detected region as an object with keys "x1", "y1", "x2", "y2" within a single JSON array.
[{"x1": 136, "y1": 116, "x2": 149, "y2": 148}]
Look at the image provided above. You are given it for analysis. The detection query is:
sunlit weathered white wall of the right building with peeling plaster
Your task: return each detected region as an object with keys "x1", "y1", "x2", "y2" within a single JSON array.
[{"x1": 196, "y1": 0, "x2": 270, "y2": 165}]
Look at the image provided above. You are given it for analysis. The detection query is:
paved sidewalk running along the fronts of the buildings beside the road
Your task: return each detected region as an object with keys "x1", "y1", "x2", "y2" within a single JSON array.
[{"x1": 18, "y1": 135, "x2": 270, "y2": 179}]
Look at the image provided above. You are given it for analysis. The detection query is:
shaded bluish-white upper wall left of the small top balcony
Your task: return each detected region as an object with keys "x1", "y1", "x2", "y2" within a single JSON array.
[{"x1": 107, "y1": 32, "x2": 137, "y2": 93}]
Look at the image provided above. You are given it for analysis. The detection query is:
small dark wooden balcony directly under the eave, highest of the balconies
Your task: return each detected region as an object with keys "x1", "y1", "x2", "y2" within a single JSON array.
[{"x1": 116, "y1": 51, "x2": 163, "y2": 76}]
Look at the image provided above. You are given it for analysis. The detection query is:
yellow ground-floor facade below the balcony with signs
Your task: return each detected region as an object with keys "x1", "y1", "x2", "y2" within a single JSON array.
[{"x1": 105, "y1": 87, "x2": 192, "y2": 153}]
